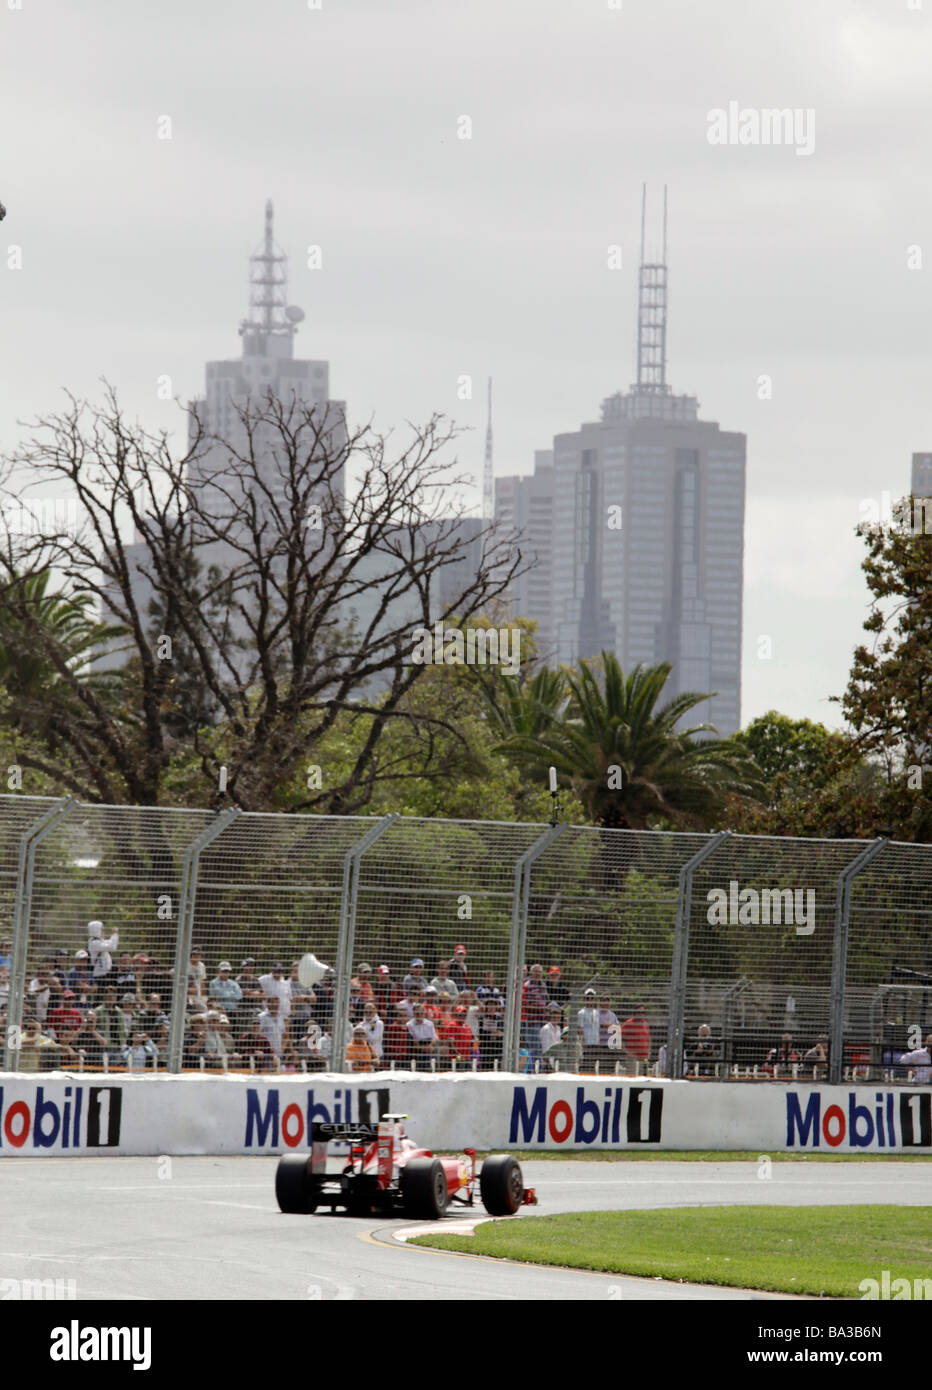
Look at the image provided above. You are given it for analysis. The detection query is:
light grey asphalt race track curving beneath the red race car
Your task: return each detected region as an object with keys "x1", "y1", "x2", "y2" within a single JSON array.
[{"x1": 0, "y1": 1158, "x2": 929, "y2": 1300}]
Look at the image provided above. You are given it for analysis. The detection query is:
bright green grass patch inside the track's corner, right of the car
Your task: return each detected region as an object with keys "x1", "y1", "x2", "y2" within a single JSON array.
[{"x1": 414, "y1": 1207, "x2": 932, "y2": 1298}]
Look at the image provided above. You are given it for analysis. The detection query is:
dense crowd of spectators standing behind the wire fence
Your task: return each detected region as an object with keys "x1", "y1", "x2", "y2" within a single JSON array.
[{"x1": 0, "y1": 922, "x2": 663, "y2": 1072}]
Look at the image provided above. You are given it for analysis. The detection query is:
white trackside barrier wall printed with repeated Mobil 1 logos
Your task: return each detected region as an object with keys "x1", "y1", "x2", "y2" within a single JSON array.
[{"x1": 0, "y1": 1073, "x2": 932, "y2": 1158}]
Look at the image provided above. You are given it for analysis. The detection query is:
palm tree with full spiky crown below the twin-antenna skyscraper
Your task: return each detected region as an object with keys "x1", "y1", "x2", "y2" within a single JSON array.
[{"x1": 497, "y1": 652, "x2": 761, "y2": 830}]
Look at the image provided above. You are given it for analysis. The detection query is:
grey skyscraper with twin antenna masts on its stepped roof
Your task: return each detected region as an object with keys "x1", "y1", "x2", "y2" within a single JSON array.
[{"x1": 496, "y1": 190, "x2": 746, "y2": 735}]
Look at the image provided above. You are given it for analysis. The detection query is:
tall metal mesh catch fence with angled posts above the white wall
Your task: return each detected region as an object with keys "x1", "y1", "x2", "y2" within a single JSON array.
[{"x1": 0, "y1": 795, "x2": 932, "y2": 1083}]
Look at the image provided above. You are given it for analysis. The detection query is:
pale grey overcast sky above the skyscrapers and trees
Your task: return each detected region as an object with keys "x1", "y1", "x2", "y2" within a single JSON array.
[{"x1": 0, "y1": 0, "x2": 932, "y2": 723}]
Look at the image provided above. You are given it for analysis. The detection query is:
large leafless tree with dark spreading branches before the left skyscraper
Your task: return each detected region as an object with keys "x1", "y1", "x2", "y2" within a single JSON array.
[{"x1": 0, "y1": 388, "x2": 521, "y2": 810}]
